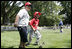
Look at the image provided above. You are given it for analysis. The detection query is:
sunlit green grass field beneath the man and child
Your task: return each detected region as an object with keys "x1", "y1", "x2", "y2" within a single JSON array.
[{"x1": 1, "y1": 29, "x2": 71, "y2": 48}]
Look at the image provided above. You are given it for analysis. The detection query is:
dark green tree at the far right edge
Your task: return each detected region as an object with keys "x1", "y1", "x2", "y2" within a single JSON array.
[{"x1": 59, "y1": 1, "x2": 71, "y2": 24}]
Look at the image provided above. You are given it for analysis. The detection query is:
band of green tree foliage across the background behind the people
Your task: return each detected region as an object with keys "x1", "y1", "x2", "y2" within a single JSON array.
[{"x1": 1, "y1": 1, "x2": 71, "y2": 26}]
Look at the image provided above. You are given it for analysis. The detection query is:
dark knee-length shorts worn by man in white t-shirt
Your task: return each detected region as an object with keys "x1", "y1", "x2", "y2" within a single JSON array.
[{"x1": 17, "y1": 26, "x2": 28, "y2": 43}]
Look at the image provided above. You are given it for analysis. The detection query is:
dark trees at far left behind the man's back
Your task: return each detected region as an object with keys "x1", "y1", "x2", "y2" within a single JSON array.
[{"x1": 1, "y1": 1, "x2": 23, "y2": 25}]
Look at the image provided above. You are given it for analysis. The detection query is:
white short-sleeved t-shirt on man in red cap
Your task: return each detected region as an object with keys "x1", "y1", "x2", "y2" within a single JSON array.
[{"x1": 17, "y1": 9, "x2": 30, "y2": 26}]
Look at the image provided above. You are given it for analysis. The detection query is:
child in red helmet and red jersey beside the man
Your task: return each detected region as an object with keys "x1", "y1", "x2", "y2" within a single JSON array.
[{"x1": 27, "y1": 12, "x2": 41, "y2": 45}]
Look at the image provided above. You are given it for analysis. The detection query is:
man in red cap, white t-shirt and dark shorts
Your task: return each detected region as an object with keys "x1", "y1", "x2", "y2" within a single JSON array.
[{"x1": 14, "y1": 2, "x2": 31, "y2": 48}]
